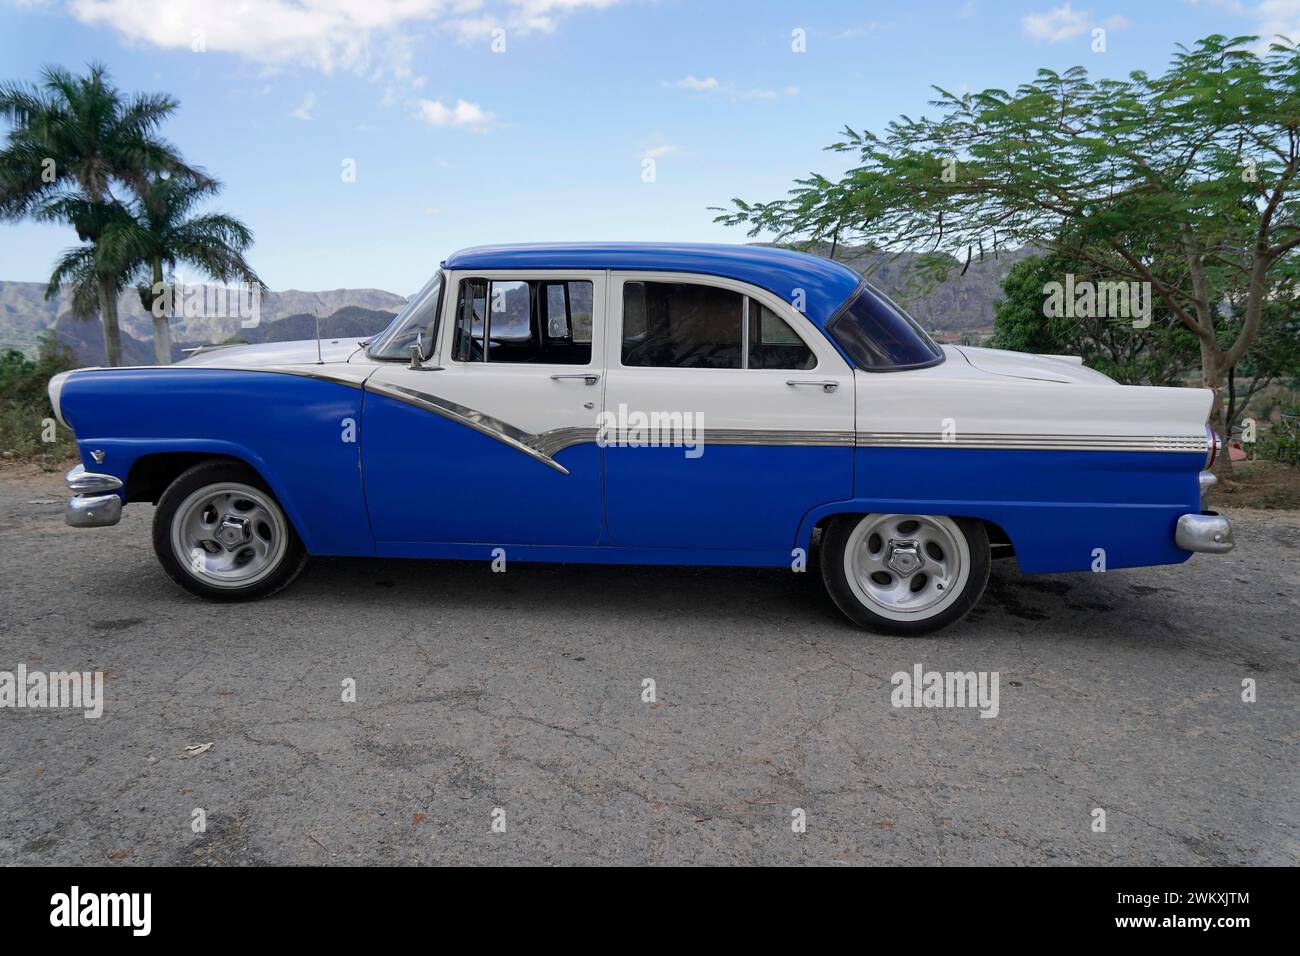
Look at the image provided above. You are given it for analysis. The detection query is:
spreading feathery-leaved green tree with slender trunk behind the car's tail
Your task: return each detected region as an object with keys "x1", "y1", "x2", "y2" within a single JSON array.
[{"x1": 719, "y1": 35, "x2": 1300, "y2": 471}]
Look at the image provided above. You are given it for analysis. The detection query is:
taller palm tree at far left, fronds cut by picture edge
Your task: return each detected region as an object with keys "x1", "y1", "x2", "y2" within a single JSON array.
[{"x1": 0, "y1": 64, "x2": 207, "y2": 365}]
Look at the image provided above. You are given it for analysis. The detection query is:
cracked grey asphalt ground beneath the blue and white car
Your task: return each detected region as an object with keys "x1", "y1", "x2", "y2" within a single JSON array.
[{"x1": 0, "y1": 467, "x2": 1300, "y2": 865}]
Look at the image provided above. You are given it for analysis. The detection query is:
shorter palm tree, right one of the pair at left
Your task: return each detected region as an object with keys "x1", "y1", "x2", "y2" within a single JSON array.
[{"x1": 109, "y1": 176, "x2": 267, "y2": 365}]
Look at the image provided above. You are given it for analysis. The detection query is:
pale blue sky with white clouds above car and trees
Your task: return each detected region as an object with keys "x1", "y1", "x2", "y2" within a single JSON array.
[{"x1": 0, "y1": 0, "x2": 1300, "y2": 295}]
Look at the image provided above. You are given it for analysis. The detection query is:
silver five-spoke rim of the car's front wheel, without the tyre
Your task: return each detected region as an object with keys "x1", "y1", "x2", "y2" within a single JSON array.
[{"x1": 172, "y1": 483, "x2": 289, "y2": 588}]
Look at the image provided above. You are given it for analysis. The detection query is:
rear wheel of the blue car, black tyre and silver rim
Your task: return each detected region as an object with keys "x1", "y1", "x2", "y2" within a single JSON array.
[{"x1": 822, "y1": 514, "x2": 991, "y2": 635}]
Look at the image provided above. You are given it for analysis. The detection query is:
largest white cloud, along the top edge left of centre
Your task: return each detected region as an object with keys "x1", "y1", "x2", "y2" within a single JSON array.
[{"x1": 68, "y1": 0, "x2": 620, "y2": 79}]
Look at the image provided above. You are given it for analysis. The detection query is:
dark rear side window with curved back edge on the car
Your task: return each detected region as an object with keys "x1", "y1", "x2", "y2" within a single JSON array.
[{"x1": 623, "y1": 281, "x2": 816, "y2": 369}]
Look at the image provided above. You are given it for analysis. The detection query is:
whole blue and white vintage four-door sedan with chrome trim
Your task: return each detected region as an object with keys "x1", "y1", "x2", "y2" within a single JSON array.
[{"x1": 49, "y1": 243, "x2": 1232, "y2": 633}]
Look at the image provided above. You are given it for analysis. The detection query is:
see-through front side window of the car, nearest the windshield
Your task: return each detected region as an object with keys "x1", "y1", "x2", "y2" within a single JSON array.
[{"x1": 451, "y1": 278, "x2": 593, "y2": 365}]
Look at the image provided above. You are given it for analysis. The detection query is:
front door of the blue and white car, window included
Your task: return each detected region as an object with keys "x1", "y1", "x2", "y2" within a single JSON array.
[{"x1": 361, "y1": 271, "x2": 606, "y2": 555}]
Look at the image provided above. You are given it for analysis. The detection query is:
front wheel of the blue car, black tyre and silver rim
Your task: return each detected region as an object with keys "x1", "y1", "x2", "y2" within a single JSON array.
[{"x1": 153, "y1": 462, "x2": 307, "y2": 601}]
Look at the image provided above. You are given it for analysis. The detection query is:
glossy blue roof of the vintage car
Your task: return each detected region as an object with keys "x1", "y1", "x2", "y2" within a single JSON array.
[{"x1": 442, "y1": 242, "x2": 862, "y2": 325}]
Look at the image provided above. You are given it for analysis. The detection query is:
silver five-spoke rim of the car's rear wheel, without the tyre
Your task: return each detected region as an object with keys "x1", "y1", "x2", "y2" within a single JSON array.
[{"x1": 844, "y1": 515, "x2": 970, "y2": 620}]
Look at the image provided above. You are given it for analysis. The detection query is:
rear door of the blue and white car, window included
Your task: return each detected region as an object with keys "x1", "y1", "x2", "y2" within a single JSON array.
[{"x1": 602, "y1": 272, "x2": 854, "y2": 548}]
